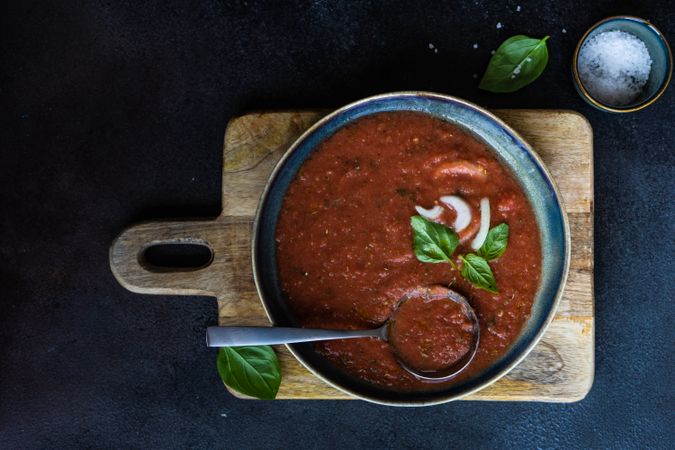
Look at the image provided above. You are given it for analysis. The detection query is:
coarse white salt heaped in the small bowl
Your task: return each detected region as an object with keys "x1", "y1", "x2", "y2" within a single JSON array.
[{"x1": 578, "y1": 30, "x2": 652, "y2": 106}]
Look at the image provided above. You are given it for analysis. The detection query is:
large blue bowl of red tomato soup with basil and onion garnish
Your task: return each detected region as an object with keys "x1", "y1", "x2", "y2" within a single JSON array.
[{"x1": 253, "y1": 93, "x2": 569, "y2": 405}]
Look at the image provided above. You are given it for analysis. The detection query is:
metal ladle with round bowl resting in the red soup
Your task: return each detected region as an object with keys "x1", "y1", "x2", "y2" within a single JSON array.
[{"x1": 206, "y1": 286, "x2": 480, "y2": 382}]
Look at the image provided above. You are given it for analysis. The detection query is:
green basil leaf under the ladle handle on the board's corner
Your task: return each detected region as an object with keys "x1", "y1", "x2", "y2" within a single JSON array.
[{"x1": 218, "y1": 345, "x2": 281, "y2": 400}]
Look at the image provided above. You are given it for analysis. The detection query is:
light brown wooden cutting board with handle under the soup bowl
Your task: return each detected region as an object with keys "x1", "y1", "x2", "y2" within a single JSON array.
[{"x1": 110, "y1": 110, "x2": 594, "y2": 402}]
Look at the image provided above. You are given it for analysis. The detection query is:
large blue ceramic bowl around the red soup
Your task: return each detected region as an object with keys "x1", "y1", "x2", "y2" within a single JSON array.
[{"x1": 252, "y1": 92, "x2": 570, "y2": 406}]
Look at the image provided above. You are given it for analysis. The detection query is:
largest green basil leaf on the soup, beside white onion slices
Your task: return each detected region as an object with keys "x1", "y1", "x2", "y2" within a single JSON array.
[{"x1": 410, "y1": 216, "x2": 459, "y2": 263}]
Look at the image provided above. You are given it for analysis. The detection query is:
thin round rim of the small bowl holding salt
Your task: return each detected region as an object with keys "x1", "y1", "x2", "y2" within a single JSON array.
[{"x1": 572, "y1": 16, "x2": 673, "y2": 113}]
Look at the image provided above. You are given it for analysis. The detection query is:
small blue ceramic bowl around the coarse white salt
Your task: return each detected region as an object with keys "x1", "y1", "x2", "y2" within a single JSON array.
[{"x1": 572, "y1": 16, "x2": 673, "y2": 113}]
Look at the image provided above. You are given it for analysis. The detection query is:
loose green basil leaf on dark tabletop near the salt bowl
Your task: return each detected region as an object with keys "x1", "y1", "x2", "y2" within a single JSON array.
[{"x1": 478, "y1": 35, "x2": 549, "y2": 93}]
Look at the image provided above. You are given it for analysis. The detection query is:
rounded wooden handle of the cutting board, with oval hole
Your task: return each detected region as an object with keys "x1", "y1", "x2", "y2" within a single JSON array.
[{"x1": 110, "y1": 218, "x2": 242, "y2": 296}]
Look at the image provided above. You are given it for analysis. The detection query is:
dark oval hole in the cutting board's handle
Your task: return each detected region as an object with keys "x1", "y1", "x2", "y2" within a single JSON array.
[{"x1": 138, "y1": 240, "x2": 213, "y2": 272}]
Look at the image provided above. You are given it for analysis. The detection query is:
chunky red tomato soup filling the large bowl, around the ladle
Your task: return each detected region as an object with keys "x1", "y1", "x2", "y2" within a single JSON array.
[{"x1": 276, "y1": 112, "x2": 541, "y2": 391}]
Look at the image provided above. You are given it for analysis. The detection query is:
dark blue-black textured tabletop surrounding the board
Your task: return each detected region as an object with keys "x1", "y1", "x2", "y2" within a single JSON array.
[{"x1": 0, "y1": 0, "x2": 675, "y2": 449}]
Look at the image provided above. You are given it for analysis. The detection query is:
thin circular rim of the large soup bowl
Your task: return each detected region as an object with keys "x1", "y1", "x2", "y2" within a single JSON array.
[{"x1": 251, "y1": 91, "x2": 571, "y2": 407}]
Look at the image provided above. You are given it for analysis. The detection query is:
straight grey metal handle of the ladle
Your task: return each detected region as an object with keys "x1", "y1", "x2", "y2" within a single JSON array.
[{"x1": 206, "y1": 327, "x2": 381, "y2": 347}]
